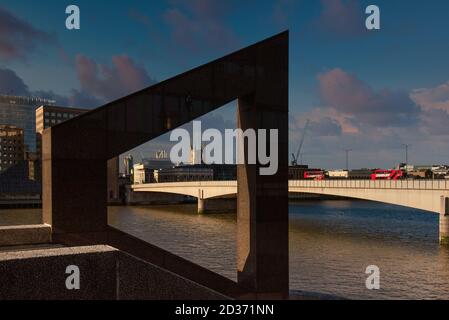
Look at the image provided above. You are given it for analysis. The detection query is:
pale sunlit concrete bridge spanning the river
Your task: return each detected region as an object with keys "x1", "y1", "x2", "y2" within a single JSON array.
[{"x1": 132, "y1": 180, "x2": 449, "y2": 244}]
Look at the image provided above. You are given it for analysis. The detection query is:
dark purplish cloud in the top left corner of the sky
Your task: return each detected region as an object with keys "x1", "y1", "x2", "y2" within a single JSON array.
[{"x1": 0, "y1": 7, "x2": 56, "y2": 61}]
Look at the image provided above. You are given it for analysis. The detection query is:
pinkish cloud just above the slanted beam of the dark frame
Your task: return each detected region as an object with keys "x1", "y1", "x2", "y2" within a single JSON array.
[{"x1": 75, "y1": 55, "x2": 155, "y2": 101}]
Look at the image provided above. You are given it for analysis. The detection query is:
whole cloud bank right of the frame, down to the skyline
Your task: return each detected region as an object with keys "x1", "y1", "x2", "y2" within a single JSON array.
[{"x1": 289, "y1": 68, "x2": 449, "y2": 168}]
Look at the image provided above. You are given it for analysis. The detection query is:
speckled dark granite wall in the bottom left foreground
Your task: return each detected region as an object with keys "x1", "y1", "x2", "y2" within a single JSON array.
[{"x1": 0, "y1": 245, "x2": 226, "y2": 300}]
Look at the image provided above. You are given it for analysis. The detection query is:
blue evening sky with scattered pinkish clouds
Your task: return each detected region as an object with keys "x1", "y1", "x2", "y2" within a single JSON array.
[{"x1": 0, "y1": 0, "x2": 449, "y2": 169}]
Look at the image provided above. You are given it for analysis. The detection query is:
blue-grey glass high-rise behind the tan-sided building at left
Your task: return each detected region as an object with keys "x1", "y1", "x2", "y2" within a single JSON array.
[{"x1": 0, "y1": 95, "x2": 55, "y2": 152}]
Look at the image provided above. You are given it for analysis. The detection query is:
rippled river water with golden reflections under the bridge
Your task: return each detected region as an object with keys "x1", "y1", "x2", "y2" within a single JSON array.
[{"x1": 0, "y1": 200, "x2": 449, "y2": 299}]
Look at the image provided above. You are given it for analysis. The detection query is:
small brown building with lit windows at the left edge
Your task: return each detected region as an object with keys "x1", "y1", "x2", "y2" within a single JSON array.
[{"x1": 0, "y1": 125, "x2": 25, "y2": 173}]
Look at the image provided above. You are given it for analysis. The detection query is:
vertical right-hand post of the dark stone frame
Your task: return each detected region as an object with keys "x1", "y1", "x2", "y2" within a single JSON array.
[{"x1": 233, "y1": 92, "x2": 289, "y2": 299}]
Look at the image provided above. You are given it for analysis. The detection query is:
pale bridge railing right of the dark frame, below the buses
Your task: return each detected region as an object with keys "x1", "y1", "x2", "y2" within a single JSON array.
[{"x1": 289, "y1": 180, "x2": 449, "y2": 190}]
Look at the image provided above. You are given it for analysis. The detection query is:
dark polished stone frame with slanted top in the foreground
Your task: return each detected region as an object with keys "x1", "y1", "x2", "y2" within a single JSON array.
[{"x1": 42, "y1": 31, "x2": 289, "y2": 298}]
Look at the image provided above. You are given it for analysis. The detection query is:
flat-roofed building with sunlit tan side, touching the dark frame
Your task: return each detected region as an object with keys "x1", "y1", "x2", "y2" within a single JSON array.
[{"x1": 35, "y1": 105, "x2": 88, "y2": 157}]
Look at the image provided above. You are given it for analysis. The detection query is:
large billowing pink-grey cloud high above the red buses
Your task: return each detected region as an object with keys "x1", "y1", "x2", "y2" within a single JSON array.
[{"x1": 308, "y1": 68, "x2": 449, "y2": 139}]
